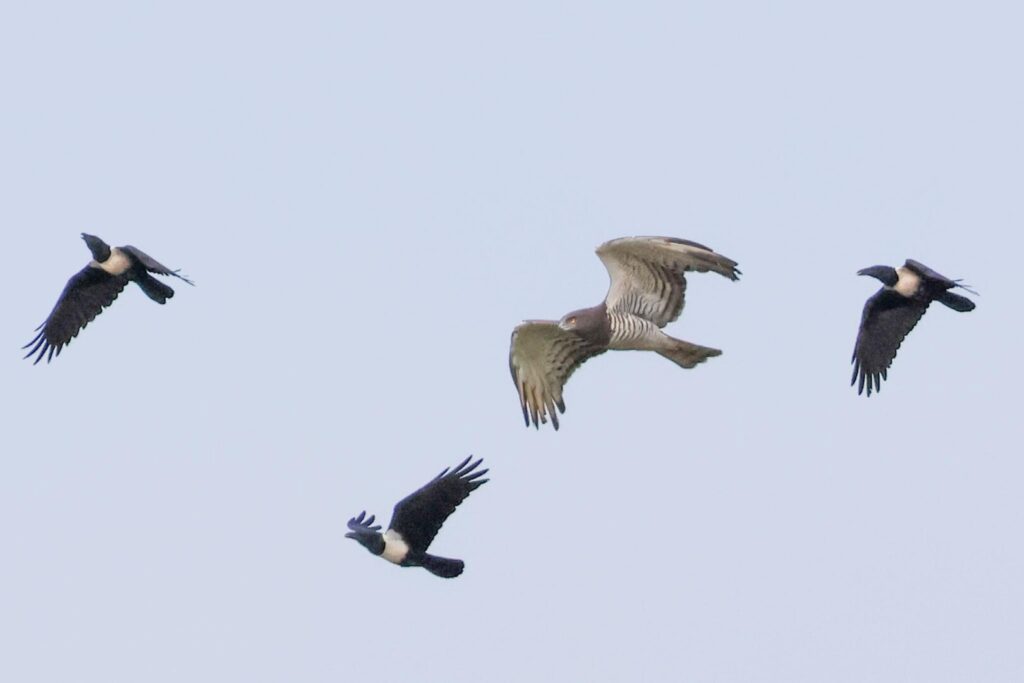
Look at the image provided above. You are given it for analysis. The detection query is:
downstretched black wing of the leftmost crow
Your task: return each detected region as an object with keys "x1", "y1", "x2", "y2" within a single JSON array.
[{"x1": 22, "y1": 265, "x2": 128, "y2": 365}]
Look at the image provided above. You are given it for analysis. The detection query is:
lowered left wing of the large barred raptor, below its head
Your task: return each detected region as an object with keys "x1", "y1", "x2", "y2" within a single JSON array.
[{"x1": 509, "y1": 321, "x2": 607, "y2": 429}]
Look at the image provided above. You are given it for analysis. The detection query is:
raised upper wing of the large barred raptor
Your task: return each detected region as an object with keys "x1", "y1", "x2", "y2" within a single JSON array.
[{"x1": 597, "y1": 238, "x2": 739, "y2": 328}]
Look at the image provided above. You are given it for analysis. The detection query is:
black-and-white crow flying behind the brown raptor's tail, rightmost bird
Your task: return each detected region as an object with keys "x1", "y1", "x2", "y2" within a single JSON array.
[{"x1": 850, "y1": 259, "x2": 977, "y2": 396}]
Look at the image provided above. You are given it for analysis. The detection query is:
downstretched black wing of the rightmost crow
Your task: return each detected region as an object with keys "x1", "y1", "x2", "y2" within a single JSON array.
[{"x1": 850, "y1": 289, "x2": 930, "y2": 396}]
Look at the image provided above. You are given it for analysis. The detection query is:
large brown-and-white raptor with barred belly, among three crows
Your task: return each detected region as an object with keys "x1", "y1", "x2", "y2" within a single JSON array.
[{"x1": 509, "y1": 237, "x2": 740, "y2": 429}]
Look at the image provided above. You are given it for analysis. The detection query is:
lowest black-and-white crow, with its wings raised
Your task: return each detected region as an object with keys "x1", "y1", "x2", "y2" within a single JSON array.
[{"x1": 345, "y1": 456, "x2": 487, "y2": 579}]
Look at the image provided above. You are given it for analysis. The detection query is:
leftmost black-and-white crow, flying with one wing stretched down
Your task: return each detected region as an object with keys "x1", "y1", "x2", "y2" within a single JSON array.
[{"x1": 22, "y1": 232, "x2": 194, "y2": 365}]
